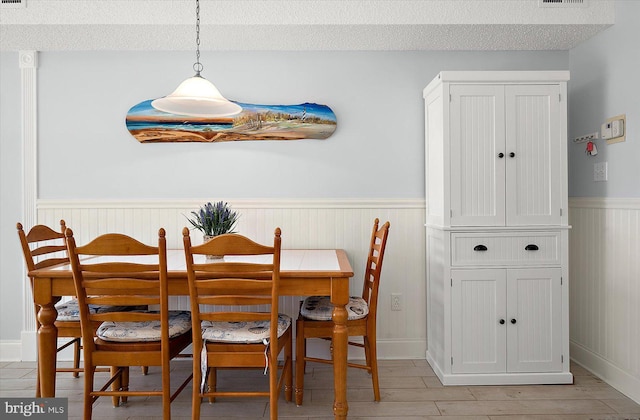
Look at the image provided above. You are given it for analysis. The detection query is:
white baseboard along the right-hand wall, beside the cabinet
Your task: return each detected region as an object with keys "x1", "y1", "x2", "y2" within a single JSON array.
[{"x1": 570, "y1": 341, "x2": 640, "y2": 404}]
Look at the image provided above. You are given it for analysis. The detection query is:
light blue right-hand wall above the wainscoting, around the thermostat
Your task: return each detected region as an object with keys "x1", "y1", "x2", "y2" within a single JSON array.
[{"x1": 569, "y1": 0, "x2": 640, "y2": 197}]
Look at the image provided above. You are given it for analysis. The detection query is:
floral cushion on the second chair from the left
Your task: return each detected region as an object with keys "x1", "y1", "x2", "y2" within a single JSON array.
[{"x1": 96, "y1": 311, "x2": 191, "y2": 342}]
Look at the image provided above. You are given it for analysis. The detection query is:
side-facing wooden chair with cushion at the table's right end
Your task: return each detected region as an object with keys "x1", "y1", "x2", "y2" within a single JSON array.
[{"x1": 295, "y1": 218, "x2": 390, "y2": 405}]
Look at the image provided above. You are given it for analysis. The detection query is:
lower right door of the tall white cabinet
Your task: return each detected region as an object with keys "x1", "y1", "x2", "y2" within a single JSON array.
[{"x1": 507, "y1": 268, "x2": 562, "y2": 372}]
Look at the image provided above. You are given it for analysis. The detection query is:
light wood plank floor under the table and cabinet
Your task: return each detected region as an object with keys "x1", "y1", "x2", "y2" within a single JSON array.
[{"x1": 0, "y1": 360, "x2": 640, "y2": 420}]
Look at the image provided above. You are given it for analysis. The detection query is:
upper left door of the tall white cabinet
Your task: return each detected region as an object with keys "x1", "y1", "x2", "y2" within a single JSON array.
[{"x1": 449, "y1": 85, "x2": 506, "y2": 226}]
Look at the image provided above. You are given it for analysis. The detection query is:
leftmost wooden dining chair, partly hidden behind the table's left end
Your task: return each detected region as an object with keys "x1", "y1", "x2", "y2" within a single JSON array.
[{"x1": 16, "y1": 220, "x2": 82, "y2": 398}]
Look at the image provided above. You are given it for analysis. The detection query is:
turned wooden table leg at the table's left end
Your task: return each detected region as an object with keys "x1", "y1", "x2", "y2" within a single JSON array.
[{"x1": 38, "y1": 302, "x2": 58, "y2": 398}]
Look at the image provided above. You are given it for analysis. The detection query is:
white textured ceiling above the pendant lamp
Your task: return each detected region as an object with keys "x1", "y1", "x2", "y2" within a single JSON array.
[{"x1": 0, "y1": 0, "x2": 615, "y2": 51}]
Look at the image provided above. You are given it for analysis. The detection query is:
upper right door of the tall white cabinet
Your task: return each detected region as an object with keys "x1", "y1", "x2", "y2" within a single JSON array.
[{"x1": 505, "y1": 85, "x2": 564, "y2": 226}]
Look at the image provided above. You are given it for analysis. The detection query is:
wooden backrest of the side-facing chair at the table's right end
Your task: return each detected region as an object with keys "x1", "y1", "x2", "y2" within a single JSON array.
[{"x1": 362, "y1": 218, "x2": 390, "y2": 321}]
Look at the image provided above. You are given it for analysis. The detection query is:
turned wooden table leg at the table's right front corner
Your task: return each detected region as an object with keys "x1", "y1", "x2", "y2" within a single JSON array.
[{"x1": 331, "y1": 279, "x2": 349, "y2": 419}]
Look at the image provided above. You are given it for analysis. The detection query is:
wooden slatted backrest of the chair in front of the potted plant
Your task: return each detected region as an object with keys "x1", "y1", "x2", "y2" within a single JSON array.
[{"x1": 182, "y1": 227, "x2": 281, "y2": 355}]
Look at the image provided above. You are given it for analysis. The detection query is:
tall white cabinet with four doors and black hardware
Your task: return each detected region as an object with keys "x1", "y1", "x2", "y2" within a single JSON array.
[{"x1": 423, "y1": 71, "x2": 573, "y2": 385}]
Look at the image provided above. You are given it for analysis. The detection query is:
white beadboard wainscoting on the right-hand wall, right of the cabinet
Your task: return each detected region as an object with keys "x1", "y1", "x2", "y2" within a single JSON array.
[{"x1": 569, "y1": 198, "x2": 640, "y2": 403}]
